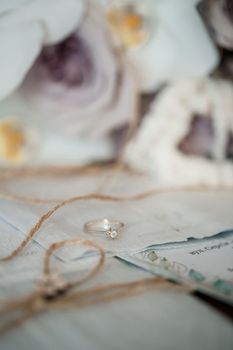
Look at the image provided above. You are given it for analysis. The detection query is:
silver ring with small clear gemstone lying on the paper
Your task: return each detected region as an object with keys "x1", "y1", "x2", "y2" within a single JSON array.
[{"x1": 83, "y1": 219, "x2": 125, "y2": 239}]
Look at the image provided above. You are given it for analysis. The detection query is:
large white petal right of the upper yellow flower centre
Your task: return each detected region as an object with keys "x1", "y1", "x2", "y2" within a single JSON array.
[{"x1": 125, "y1": 0, "x2": 218, "y2": 91}]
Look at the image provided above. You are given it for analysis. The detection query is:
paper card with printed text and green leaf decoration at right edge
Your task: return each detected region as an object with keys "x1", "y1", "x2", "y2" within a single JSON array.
[{"x1": 120, "y1": 230, "x2": 233, "y2": 304}]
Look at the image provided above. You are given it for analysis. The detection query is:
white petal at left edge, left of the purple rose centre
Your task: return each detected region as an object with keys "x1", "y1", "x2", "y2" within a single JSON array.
[{"x1": 0, "y1": 23, "x2": 42, "y2": 100}]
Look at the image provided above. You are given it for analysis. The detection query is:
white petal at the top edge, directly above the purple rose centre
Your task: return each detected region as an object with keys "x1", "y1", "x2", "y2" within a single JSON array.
[{"x1": 1, "y1": 0, "x2": 85, "y2": 44}]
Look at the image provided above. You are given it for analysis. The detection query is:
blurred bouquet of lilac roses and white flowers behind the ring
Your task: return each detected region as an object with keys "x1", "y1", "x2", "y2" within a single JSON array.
[{"x1": 0, "y1": 0, "x2": 233, "y2": 186}]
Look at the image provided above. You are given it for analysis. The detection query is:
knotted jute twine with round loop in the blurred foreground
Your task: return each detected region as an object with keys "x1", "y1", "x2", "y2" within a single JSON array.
[{"x1": 0, "y1": 238, "x2": 191, "y2": 335}]
